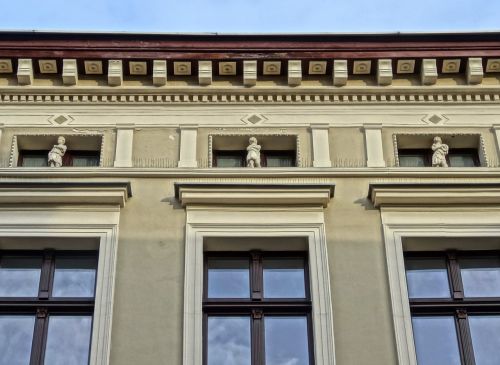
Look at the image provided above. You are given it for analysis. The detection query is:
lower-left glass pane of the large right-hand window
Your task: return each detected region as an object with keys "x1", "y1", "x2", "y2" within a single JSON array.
[{"x1": 412, "y1": 316, "x2": 461, "y2": 365}]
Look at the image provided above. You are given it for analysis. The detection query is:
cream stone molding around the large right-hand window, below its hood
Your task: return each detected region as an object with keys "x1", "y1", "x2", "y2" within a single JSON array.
[{"x1": 381, "y1": 205, "x2": 500, "y2": 365}]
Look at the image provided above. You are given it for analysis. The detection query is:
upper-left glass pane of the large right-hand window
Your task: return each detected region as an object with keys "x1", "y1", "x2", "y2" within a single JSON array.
[{"x1": 405, "y1": 258, "x2": 450, "y2": 298}]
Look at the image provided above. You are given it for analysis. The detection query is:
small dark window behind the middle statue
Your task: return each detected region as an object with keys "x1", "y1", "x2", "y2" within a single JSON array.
[{"x1": 213, "y1": 151, "x2": 295, "y2": 167}]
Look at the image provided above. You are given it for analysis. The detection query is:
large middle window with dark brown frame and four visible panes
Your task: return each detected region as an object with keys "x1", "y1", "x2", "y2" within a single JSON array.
[{"x1": 203, "y1": 251, "x2": 314, "y2": 365}]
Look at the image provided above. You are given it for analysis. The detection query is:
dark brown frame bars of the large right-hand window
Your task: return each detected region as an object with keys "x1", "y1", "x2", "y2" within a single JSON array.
[{"x1": 405, "y1": 250, "x2": 500, "y2": 365}]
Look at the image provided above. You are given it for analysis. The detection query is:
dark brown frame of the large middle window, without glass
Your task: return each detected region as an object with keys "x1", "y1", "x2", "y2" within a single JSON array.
[{"x1": 202, "y1": 251, "x2": 314, "y2": 365}]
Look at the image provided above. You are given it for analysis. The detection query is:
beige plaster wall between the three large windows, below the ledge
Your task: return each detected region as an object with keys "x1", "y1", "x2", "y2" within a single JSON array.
[{"x1": 107, "y1": 175, "x2": 396, "y2": 365}]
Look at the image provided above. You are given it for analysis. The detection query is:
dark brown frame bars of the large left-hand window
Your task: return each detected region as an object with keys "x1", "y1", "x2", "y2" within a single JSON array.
[{"x1": 0, "y1": 249, "x2": 98, "y2": 365}]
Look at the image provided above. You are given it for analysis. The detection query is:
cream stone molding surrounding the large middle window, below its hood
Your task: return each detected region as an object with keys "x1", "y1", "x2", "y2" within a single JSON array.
[{"x1": 182, "y1": 205, "x2": 335, "y2": 365}]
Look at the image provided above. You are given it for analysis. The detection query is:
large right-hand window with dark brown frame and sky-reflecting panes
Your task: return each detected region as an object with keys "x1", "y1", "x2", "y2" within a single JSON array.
[{"x1": 405, "y1": 251, "x2": 500, "y2": 365}]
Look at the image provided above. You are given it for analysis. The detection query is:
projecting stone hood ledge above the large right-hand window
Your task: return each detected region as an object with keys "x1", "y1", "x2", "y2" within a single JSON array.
[{"x1": 368, "y1": 183, "x2": 500, "y2": 208}]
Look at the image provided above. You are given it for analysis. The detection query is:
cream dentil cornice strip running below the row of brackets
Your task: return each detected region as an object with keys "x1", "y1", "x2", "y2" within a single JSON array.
[{"x1": 0, "y1": 86, "x2": 500, "y2": 106}]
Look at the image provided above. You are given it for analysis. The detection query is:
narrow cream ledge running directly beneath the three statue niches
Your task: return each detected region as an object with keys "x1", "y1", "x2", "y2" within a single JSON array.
[{"x1": 0, "y1": 167, "x2": 500, "y2": 178}]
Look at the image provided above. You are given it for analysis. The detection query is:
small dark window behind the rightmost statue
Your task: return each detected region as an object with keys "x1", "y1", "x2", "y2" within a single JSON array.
[{"x1": 398, "y1": 148, "x2": 480, "y2": 167}]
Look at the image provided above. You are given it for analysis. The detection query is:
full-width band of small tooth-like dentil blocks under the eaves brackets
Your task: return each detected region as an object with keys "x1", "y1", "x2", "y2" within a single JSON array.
[{"x1": 0, "y1": 87, "x2": 500, "y2": 105}]
